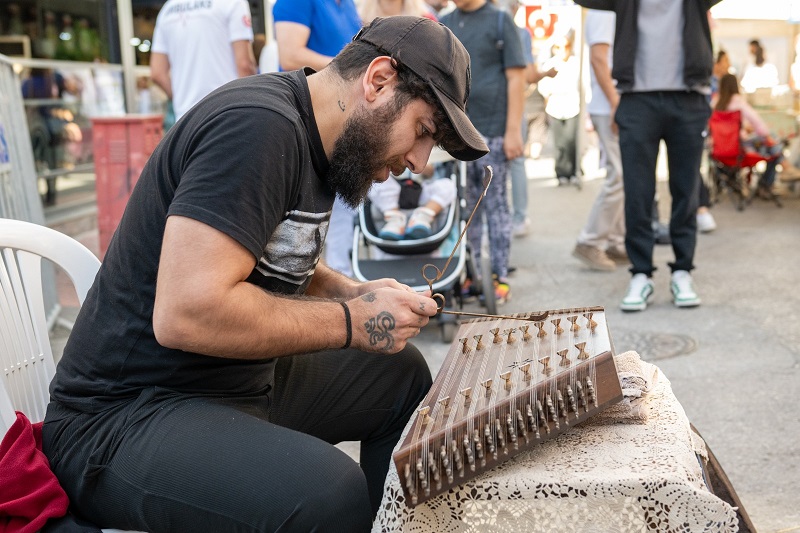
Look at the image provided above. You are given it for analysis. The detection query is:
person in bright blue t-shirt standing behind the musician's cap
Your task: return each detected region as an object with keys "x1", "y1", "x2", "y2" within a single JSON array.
[{"x1": 272, "y1": 0, "x2": 361, "y2": 276}]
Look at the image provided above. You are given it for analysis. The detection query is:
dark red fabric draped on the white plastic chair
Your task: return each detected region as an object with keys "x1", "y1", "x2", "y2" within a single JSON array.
[{"x1": 0, "y1": 412, "x2": 69, "y2": 533}]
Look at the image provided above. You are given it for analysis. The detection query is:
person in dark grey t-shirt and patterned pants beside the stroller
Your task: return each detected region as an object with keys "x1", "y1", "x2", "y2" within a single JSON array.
[{"x1": 440, "y1": 0, "x2": 525, "y2": 304}]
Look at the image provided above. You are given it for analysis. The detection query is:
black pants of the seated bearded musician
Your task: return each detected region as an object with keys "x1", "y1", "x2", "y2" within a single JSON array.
[{"x1": 44, "y1": 346, "x2": 431, "y2": 533}]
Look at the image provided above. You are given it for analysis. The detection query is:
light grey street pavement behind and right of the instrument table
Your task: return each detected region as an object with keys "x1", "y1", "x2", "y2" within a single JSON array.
[{"x1": 48, "y1": 151, "x2": 800, "y2": 533}]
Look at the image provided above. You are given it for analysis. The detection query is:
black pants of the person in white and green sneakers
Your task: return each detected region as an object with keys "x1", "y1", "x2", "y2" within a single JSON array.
[{"x1": 615, "y1": 91, "x2": 711, "y2": 276}]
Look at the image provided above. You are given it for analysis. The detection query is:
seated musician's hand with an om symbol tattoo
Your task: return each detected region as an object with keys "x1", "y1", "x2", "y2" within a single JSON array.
[{"x1": 347, "y1": 286, "x2": 437, "y2": 354}]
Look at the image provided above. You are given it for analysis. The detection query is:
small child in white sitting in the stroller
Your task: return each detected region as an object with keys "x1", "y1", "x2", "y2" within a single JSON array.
[{"x1": 369, "y1": 165, "x2": 456, "y2": 241}]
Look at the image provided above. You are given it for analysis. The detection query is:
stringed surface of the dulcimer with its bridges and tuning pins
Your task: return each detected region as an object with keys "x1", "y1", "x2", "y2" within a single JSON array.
[{"x1": 403, "y1": 308, "x2": 612, "y2": 502}]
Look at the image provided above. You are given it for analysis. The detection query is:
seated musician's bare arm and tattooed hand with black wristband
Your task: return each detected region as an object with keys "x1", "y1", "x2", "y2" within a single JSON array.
[{"x1": 152, "y1": 216, "x2": 436, "y2": 359}]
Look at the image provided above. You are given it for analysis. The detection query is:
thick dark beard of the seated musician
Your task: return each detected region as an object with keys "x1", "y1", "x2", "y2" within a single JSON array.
[{"x1": 328, "y1": 101, "x2": 402, "y2": 209}]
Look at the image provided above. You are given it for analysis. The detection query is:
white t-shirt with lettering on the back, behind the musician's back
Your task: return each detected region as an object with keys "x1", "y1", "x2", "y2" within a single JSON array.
[{"x1": 152, "y1": 0, "x2": 253, "y2": 118}]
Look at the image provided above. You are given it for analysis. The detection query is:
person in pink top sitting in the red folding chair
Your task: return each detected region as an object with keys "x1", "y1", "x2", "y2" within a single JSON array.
[{"x1": 711, "y1": 74, "x2": 800, "y2": 189}]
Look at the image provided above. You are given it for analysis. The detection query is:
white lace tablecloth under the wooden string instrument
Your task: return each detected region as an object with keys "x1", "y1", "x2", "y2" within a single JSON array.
[{"x1": 372, "y1": 354, "x2": 738, "y2": 533}]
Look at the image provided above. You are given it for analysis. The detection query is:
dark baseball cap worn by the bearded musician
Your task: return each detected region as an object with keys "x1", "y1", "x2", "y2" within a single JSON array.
[{"x1": 353, "y1": 16, "x2": 489, "y2": 161}]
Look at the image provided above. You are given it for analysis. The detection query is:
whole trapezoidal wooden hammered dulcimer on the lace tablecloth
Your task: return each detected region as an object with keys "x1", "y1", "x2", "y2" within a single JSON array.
[{"x1": 393, "y1": 307, "x2": 622, "y2": 507}]
